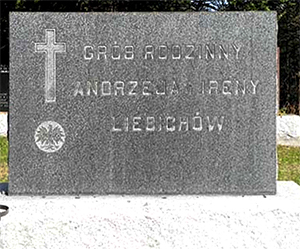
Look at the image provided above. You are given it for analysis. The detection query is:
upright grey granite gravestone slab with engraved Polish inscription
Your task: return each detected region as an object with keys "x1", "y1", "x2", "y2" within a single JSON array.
[{"x1": 9, "y1": 12, "x2": 277, "y2": 195}]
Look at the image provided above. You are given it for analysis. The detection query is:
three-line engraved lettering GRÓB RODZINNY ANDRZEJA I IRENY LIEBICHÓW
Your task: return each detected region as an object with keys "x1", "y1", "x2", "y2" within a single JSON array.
[{"x1": 73, "y1": 43, "x2": 259, "y2": 132}]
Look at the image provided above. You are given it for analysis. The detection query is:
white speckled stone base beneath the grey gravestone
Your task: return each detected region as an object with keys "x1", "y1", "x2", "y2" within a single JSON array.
[{"x1": 0, "y1": 182, "x2": 300, "y2": 249}]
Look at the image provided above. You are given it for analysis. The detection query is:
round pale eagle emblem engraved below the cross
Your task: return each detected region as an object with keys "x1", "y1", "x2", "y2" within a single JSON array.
[{"x1": 34, "y1": 121, "x2": 66, "y2": 153}]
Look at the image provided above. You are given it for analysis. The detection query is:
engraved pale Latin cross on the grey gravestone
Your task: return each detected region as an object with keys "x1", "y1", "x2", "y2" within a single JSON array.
[{"x1": 35, "y1": 29, "x2": 66, "y2": 103}]
